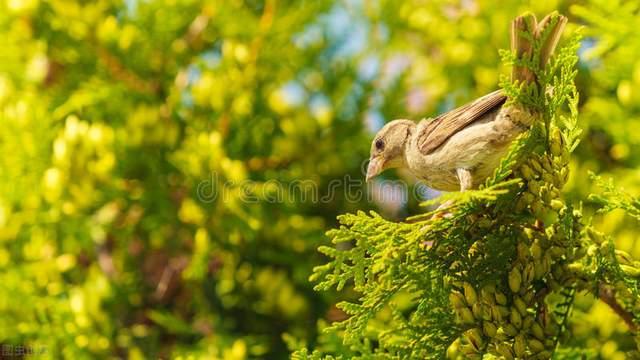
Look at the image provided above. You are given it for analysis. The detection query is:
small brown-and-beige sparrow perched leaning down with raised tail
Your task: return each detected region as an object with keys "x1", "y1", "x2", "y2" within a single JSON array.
[{"x1": 366, "y1": 12, "x2": 567, "y2": 195}]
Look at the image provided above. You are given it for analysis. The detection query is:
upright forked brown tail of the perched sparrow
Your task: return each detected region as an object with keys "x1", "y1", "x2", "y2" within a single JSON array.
[{"x1": 511, "y1": 11, "x2": 567, "y2": 83}]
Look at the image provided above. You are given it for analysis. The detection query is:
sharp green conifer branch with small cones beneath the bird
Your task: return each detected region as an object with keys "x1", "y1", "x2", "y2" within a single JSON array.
[{"x1": 299, "y1": 10, "x2": 640, "y2": 359}]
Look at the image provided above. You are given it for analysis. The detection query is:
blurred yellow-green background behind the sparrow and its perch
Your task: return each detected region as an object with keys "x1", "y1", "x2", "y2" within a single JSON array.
[{"x1": 0, "y1": 0, "x2": 640, "y2": 359}]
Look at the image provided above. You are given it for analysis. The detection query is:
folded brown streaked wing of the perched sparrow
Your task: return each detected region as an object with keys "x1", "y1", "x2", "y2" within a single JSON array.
[{"x1": 417, "y1": 90, "x2": 507, "y2": 155}]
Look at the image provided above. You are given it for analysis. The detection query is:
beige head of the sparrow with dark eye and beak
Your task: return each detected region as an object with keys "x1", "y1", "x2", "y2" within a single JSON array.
[{"x1": 367, "y1": 120, "x2": 416, "y2": 181}]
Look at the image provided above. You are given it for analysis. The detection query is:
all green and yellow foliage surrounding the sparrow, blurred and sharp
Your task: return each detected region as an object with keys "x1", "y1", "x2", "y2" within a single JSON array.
[{"x1": 0, "y1": 0, "x2": 640, "y2": 359}]
